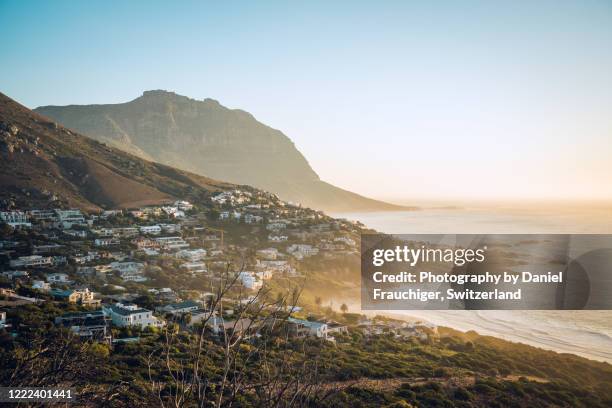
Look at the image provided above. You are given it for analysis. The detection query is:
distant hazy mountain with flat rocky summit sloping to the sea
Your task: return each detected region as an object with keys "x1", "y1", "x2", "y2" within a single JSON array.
[{"x1": 35, "y1": 90, "x2": 406, "y2": 211}]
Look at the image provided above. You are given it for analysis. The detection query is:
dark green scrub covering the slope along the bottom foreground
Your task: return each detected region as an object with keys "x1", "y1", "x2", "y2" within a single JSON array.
[{"x1": 0, "y1": 302, "x2": 612, "y2": 407}]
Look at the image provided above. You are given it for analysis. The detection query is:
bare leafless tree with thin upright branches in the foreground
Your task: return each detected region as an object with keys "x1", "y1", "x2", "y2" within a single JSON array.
[{"x1": 146, "y1": 265, "x2": 339, "y2": 408}]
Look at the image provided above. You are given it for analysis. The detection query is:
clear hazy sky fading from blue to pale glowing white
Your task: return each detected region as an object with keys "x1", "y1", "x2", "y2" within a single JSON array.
[{"x1": 0, "y1": 0, "x2": 612, "y2": 202}]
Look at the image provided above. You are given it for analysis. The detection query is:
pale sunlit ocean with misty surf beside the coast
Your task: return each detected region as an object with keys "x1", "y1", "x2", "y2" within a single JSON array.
[{"x1": 331, "y1": 205, "x2": 612, "y2": 362}]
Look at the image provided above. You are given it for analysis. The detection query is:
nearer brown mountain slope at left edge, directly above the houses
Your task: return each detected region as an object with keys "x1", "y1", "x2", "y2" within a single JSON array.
[{"x1": 0, "y1": 93, "x2": 232, "y2": 210}]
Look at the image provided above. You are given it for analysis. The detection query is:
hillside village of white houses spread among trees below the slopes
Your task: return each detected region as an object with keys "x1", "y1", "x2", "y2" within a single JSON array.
[{"x1": 0, "y1": 189, "x2": 436, "y2": 346}]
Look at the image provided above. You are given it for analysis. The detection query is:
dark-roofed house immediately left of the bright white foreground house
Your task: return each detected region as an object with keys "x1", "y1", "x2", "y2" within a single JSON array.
[{"x1": 55, "y1": 310, "x2": 112, "y2": 345}]
